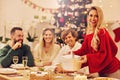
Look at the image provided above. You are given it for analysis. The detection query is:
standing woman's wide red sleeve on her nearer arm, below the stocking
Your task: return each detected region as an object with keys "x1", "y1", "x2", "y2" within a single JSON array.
[{"x1": 87, "y1": 30, "x2": 117, "y2": 73}]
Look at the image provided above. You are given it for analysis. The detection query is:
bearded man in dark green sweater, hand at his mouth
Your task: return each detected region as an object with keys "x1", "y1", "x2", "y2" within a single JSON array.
[{"x1": 0, "y1": 27, "x2": 34, "y2": 68}]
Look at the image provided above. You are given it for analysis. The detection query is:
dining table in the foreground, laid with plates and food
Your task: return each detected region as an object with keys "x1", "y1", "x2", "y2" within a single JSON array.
[{"x1": 0, "y1": 67, "x2": 119, "y2": 80}]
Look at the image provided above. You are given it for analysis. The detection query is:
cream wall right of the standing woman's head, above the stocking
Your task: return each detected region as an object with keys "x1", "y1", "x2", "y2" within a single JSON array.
[{"x1": 92, "y1": 0, "x2": 120, "y2": 22}]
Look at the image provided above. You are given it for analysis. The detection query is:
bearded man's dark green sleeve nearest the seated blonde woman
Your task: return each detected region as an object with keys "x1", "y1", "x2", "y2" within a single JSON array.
[{"x1": 25, "y1": 45, "x2": 35, "y2": 67}]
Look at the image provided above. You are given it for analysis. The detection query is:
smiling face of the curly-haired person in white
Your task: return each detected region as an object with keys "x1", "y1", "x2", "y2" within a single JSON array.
[{"x1": 64, "y1": 33, "x2": 76, "y2": 48}]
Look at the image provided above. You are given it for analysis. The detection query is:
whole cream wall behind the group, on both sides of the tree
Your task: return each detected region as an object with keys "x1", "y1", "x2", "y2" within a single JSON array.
[{"x1": 0, "y1": 0, "x2": 120, "y2": 58}]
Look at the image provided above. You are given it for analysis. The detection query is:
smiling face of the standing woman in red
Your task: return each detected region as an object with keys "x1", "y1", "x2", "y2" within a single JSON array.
[{"x1": 87, "y1": 9, "x2": 98, "y2": 28}]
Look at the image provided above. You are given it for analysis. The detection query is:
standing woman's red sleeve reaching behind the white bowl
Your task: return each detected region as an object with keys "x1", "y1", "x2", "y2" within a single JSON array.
[{"x1": 73, "y1": 36, "x2": 88, "y2": 56}]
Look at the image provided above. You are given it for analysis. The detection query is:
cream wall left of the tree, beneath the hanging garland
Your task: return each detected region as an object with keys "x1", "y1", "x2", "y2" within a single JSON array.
[{"x1": 0, "y1": 0, "x2": 52, "y2": 37}]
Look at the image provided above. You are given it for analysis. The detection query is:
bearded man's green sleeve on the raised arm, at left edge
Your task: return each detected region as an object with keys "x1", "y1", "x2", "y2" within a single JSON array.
[{"x1": 0, "y1": 46, "x2": 15, "y2": 68}]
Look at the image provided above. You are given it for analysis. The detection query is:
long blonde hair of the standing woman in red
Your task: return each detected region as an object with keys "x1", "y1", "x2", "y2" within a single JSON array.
[{"x1": 86, "y1": 6, "x2": 103, "y2": 51}]
